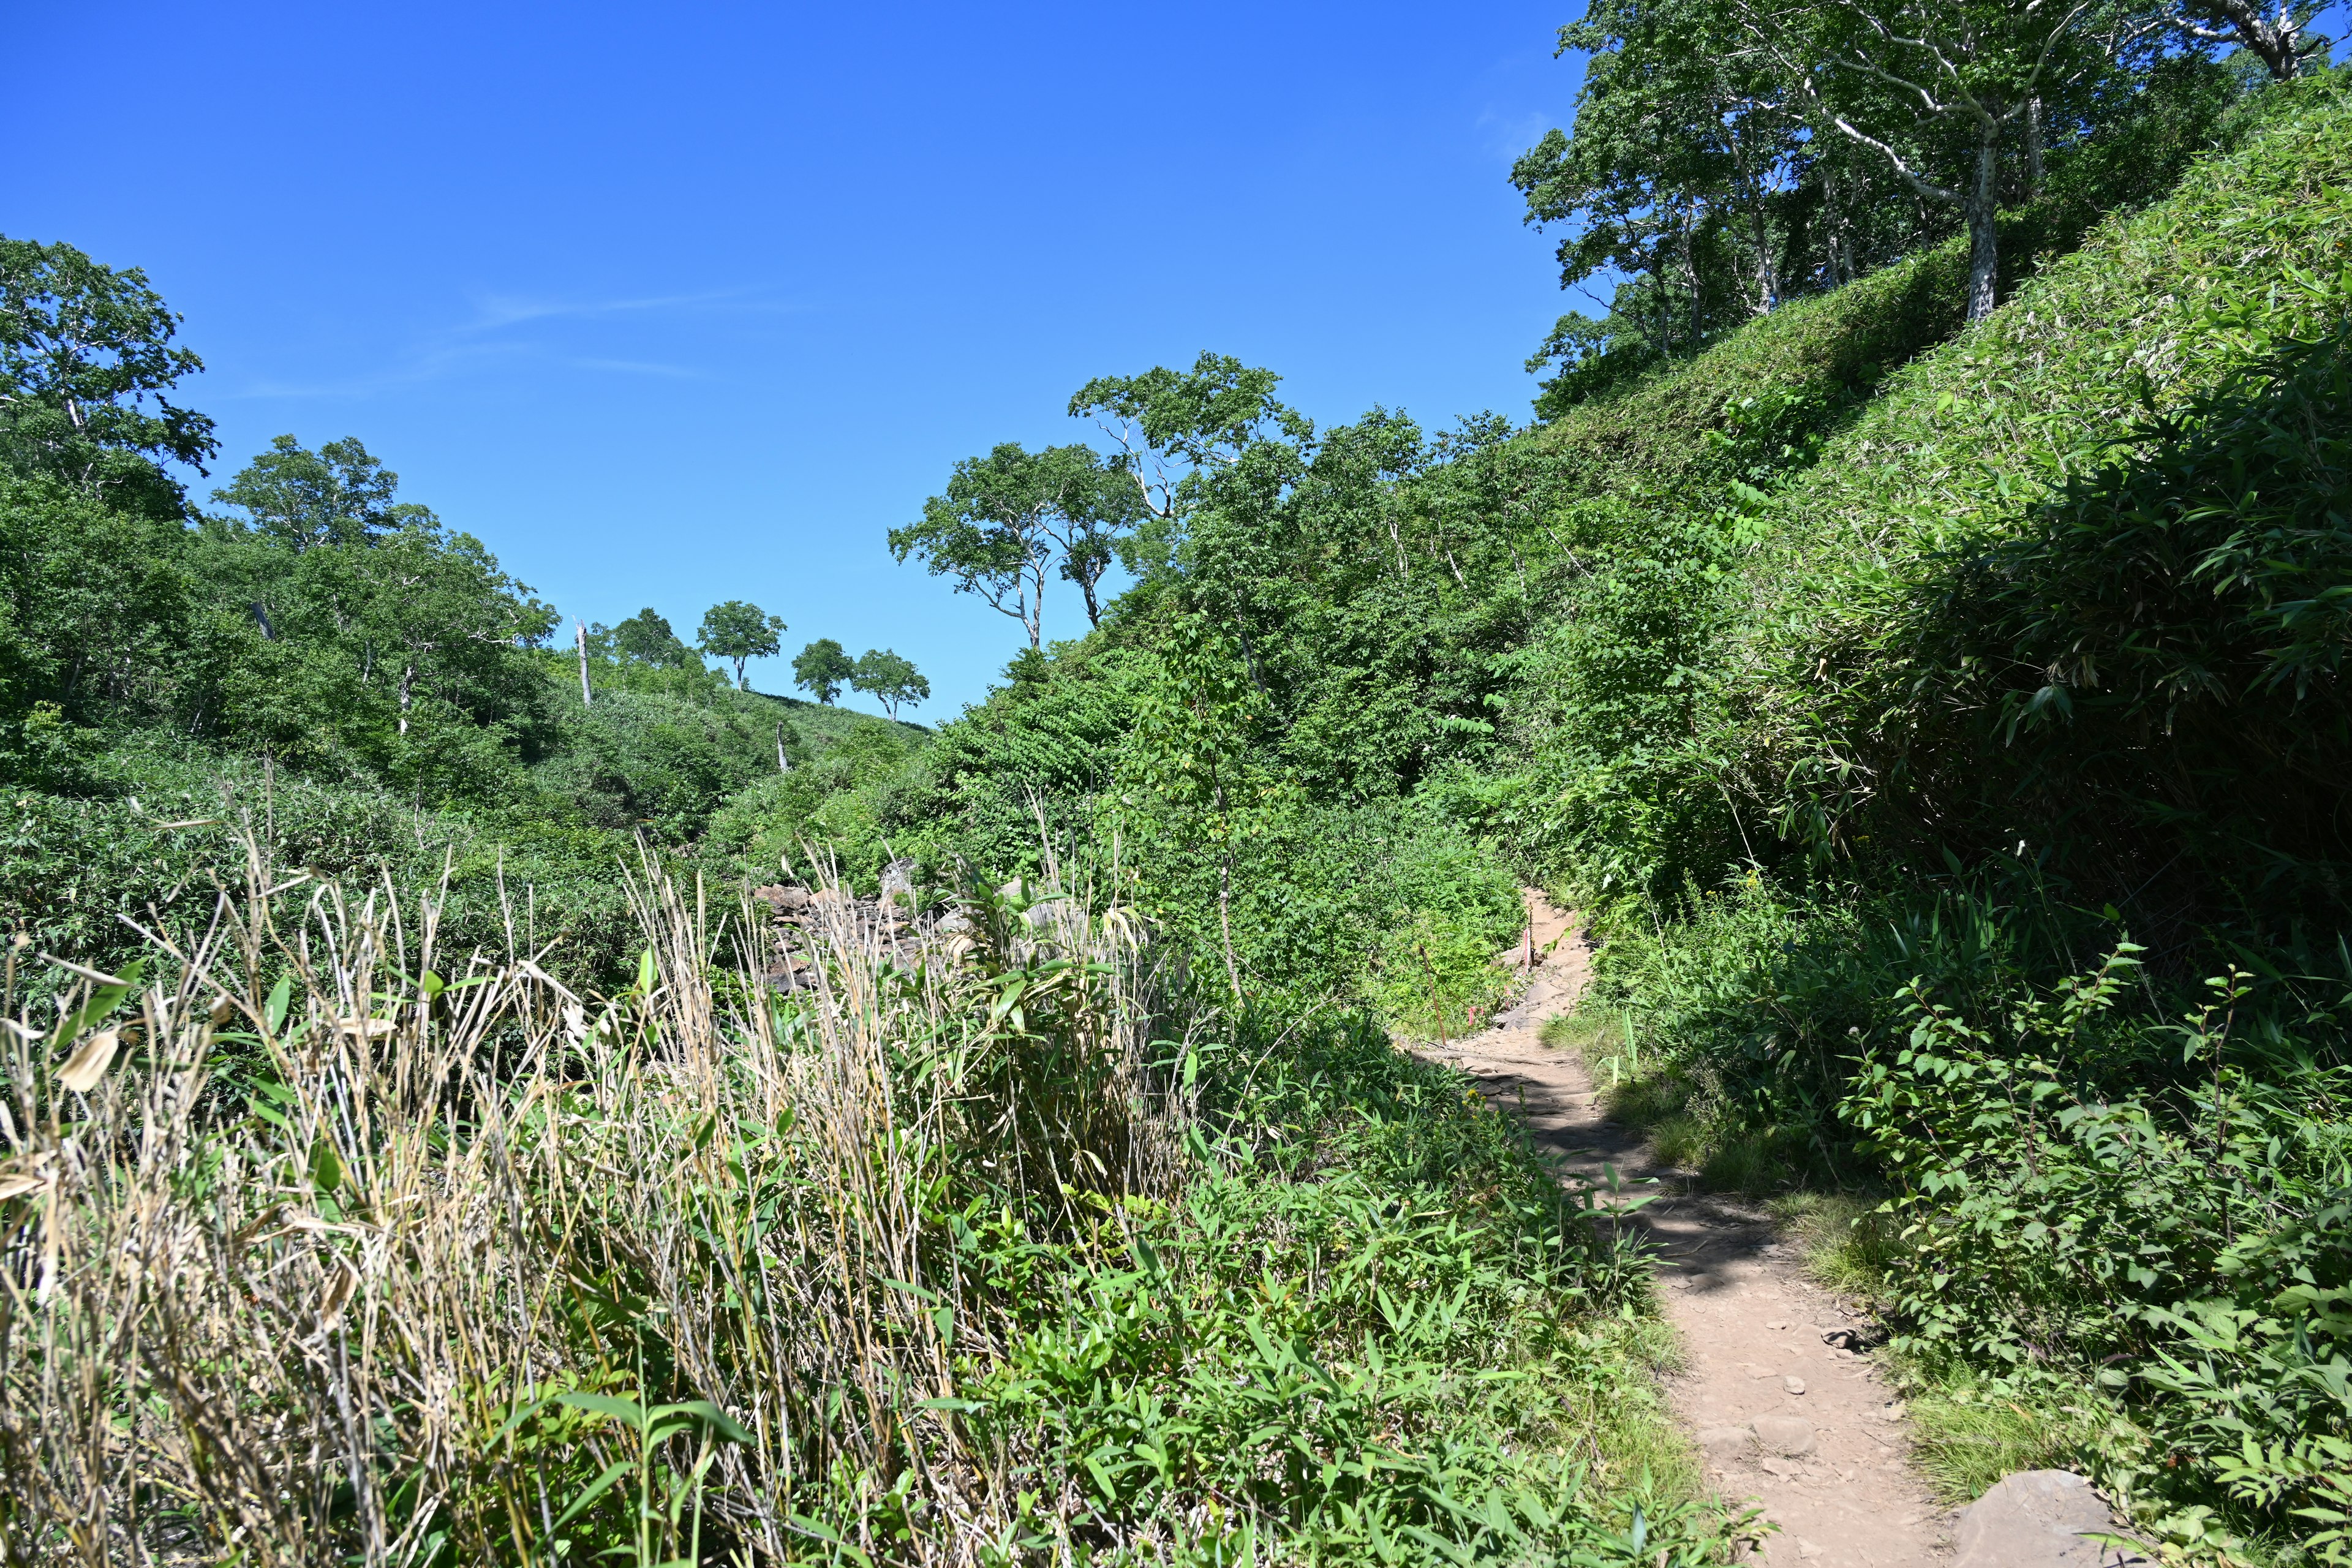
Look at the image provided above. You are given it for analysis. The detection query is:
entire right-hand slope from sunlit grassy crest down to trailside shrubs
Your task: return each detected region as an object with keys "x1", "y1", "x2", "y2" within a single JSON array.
[{"x1": 1534, "y1": 75, "x2": 2352, "y2": 1563}]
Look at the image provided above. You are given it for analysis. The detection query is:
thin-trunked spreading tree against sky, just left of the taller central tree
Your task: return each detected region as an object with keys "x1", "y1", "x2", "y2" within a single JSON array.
[{"x1": 889, "y1": 442, "x2": 1140, "y2": 649}]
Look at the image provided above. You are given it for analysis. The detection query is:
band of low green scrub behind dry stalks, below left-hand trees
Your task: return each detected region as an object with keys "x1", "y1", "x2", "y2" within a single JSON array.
[{"x1": 0, "y1": 682, "x2": 924, "y2": 1001}]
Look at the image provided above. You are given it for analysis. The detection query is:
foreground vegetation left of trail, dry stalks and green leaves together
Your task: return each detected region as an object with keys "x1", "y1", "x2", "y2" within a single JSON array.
[{"x1": 0, "y1": 851, "x2": 1731, "y2": 1563}]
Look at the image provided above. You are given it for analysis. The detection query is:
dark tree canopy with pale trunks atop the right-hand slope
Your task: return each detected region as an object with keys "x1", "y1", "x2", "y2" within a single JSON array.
[{"x1": 1510, "y1": 0, "x2": 2321, "y2": 399}]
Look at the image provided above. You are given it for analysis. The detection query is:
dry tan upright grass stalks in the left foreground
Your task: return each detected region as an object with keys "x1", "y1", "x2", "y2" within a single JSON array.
[{"x1": 0, "y1": 851, "x2": 1171, "y2": 1563}]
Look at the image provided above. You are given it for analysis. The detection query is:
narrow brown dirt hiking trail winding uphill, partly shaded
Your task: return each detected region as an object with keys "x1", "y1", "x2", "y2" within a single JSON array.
[{"x1": 1420, "y1": 895, "x2": 1952, "y2": 1568}]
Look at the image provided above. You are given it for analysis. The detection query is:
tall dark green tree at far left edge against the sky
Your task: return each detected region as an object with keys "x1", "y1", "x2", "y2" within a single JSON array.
[{"x1": 0, "y1": 238, "x2": 219, "y2": 515}]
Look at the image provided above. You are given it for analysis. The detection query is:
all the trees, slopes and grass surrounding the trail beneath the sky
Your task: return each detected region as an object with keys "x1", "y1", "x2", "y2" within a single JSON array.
[{"x1": 0, "y1": 0, "x2": 2352, "y2": 1566}]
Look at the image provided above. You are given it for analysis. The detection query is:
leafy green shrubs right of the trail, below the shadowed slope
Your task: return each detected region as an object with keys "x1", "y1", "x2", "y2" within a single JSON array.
[{"x1": 1557, "y1": 886, "x2": 2352, "y2": 1561}]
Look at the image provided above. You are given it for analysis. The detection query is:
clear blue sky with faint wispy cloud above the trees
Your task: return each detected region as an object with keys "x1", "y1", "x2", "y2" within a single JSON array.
[{"x1": 0, "y1": 0, "x2": 1580, "y2": 722}]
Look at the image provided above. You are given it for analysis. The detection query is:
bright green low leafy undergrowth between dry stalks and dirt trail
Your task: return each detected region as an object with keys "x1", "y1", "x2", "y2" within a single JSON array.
[{"x1": 967, "y1": 1011, "x2": 1727, "y2": 1563}]
